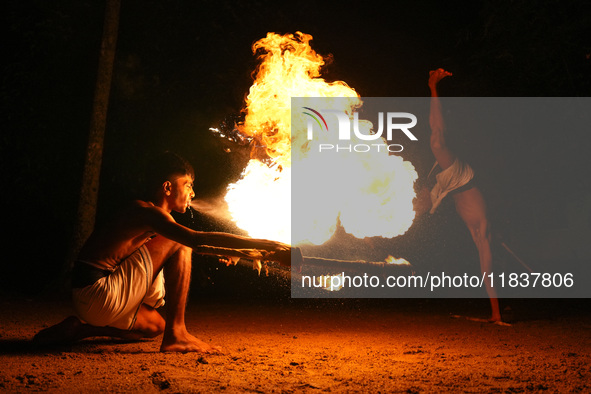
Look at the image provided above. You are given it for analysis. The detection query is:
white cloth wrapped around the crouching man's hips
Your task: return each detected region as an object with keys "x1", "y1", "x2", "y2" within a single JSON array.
[{"x1": 72, "y1": 245, "x2": 165, "y2": 330}]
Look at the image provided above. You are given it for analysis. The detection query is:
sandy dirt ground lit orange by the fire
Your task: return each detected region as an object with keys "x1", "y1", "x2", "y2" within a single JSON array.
[{"x1": 0, "y1": 290, "x2": 591, "y2": 393}]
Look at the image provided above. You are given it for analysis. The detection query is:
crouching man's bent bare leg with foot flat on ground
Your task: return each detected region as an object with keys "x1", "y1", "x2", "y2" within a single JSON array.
[{"x1": 148, "y1": 237, "x2": 221, "y2": 353}]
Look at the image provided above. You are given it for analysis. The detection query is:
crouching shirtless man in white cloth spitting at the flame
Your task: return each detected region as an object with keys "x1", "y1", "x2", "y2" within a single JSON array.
[{"x1": 34, "y1": 152, "x2": 290, "y2": 353}]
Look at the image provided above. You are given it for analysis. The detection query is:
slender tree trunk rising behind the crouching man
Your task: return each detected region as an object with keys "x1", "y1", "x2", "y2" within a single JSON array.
[{"x1": 60, "y1": 0, "x2": 121, "y2": 289}]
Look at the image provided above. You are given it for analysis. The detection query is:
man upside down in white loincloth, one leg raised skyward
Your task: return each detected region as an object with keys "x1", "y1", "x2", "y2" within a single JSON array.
[{"x1": 419, "y1": 68, "x2": 501, "y2": 322}]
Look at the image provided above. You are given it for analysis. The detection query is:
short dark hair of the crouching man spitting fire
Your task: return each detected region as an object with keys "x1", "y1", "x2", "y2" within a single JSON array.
[{"x1": 143, "y1": 151, "x2": 195, "y2": 199}]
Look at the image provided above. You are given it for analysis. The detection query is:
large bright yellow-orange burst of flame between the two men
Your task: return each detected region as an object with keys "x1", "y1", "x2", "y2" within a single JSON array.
[{"x1": 225, "y1": 32, "x2": 417, "y2": 245}]
